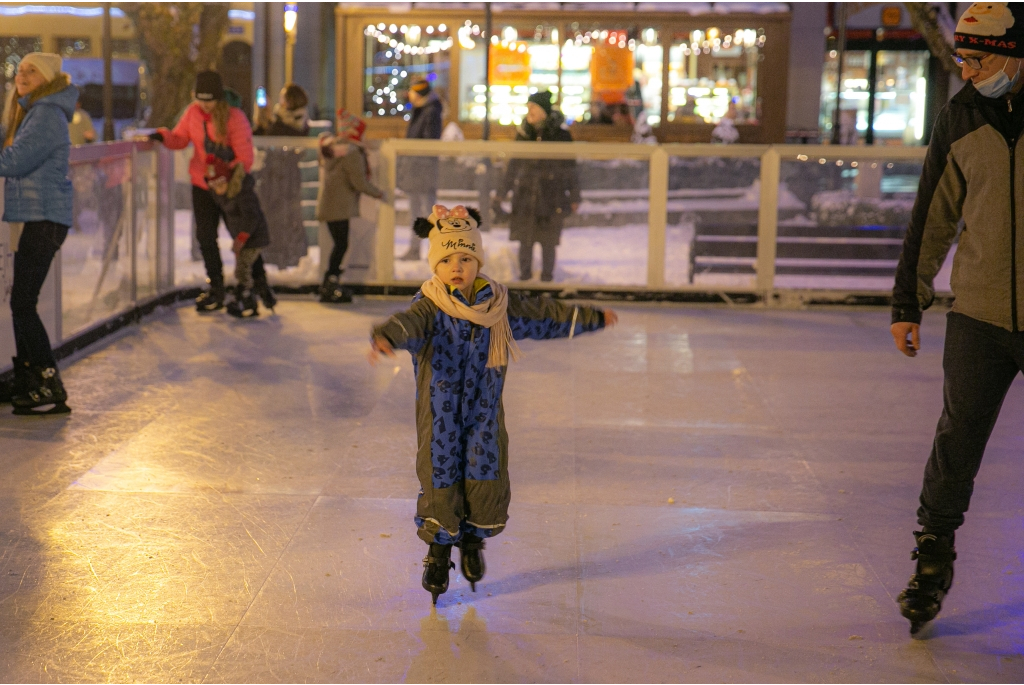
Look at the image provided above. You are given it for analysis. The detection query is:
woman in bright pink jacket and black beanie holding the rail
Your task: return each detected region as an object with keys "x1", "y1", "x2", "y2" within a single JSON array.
[{"x1": 150, "y1": 72, "x2": 278, "y2": 311}]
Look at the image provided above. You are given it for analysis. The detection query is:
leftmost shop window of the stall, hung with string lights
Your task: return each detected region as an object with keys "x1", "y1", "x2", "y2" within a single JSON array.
[{"x1": 362, "y1": 23, "x2": 454, "y2": 119}]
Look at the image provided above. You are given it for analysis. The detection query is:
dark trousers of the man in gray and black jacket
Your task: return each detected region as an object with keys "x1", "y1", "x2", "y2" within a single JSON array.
[{"x1": 918, "y1": 312, "x2": 1024, "y2": 532}]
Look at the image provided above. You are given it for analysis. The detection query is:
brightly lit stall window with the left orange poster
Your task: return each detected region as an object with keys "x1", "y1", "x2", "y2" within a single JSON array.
[{"x1": 458, "y1": 22, "x2": 558, "y2": 125}]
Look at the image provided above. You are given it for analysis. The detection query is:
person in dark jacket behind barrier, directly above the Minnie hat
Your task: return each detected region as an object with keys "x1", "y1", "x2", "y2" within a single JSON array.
[{"x1": 396, "y1": 80, "x2": 444, "y2": 261}]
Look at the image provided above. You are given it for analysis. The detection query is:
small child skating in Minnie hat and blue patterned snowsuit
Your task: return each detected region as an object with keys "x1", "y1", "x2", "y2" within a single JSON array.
[{"x1": 370, "y1": 205, "x2": 617, "y2": 605}]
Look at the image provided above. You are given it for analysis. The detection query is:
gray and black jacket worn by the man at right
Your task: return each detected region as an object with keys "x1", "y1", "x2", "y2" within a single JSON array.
[{"x1": 892, "y1": 83, "x2": 1024, "y2": 332}]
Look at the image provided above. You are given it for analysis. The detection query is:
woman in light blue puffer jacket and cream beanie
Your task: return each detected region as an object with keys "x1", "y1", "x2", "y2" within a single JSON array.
[{"x1": 0, "y1": 52, "x2": 78, "y2": 414}]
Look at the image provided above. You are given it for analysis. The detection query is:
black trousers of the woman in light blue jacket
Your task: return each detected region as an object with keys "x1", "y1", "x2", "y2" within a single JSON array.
[{"x1": 10, "y1": 221, "x2": 69, "y2": 367}]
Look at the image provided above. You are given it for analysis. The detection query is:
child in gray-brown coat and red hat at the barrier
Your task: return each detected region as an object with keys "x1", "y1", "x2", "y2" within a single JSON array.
[{"x1": 316, "y1": 110, "x2": 384, "y2": 302}]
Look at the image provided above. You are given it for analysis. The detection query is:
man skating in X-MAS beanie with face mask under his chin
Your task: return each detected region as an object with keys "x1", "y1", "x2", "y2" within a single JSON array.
[{"x1": 891, "y1": 3, "x2": 1024, "y2": 633}]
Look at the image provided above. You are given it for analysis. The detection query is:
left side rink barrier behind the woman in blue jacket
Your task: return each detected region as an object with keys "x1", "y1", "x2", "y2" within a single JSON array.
[{"x1": 0, "y1": 141, "x2": 174, "y2": 371}]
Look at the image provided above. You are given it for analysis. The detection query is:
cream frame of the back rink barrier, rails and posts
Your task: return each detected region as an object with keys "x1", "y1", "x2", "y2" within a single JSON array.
[{"x1": 374, "y1": 138, "x2": 927, "y2": 299}]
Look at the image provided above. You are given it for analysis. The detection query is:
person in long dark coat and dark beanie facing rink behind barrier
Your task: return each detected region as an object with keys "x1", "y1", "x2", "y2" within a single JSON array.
[{"x1": 495, "y1": 92, "x2": 580, "y2": 281}]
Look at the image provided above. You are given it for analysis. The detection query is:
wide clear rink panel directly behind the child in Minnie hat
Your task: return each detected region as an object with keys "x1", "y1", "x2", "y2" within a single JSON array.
[{"x1": 394, "y1": 154, "x2": 648, "y2": 286}]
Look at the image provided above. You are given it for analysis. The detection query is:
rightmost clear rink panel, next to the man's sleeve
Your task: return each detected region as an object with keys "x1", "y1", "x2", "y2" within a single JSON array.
[{"x1": 775, "y1": 149, "x2": 942, "y2": 292}]
